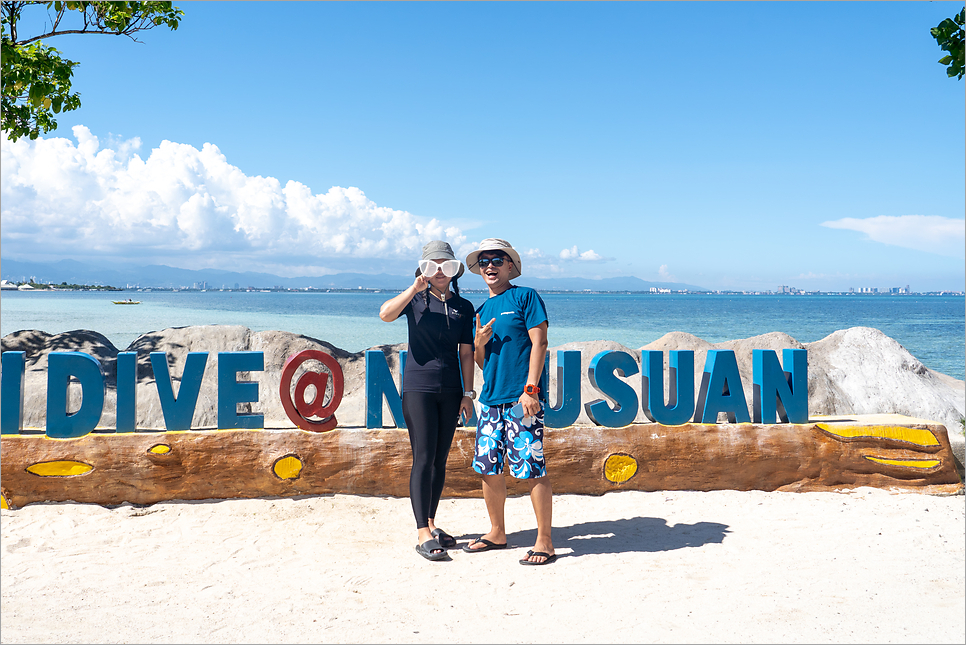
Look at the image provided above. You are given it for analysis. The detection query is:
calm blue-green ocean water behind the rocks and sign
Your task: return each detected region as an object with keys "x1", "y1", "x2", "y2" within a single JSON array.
[{"x1": 0, "y1": 291, "x2": 966, "y2": 379}]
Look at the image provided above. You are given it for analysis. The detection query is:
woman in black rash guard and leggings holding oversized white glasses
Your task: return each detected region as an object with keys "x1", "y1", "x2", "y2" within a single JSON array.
[{"x1": 379, "y1": 240, "x2": 476, "y2": 560}]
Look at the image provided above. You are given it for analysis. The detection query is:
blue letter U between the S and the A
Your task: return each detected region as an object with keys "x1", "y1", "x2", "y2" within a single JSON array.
[{"x1": 641, "y1": 350, "x2": 694, "y2": 426}]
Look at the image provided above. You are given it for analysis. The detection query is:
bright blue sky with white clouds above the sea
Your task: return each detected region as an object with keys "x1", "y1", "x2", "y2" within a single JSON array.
[{"x1": 0, "y1": 2, "x2": 966, "y2": 290}]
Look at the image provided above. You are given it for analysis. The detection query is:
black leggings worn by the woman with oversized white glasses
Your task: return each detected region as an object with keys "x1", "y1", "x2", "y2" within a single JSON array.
[{"x1": 403, "y1": 392, "x2": 463, "y2": 529}]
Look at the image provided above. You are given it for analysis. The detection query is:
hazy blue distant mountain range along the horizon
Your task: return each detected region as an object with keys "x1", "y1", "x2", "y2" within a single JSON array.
[{"x1": 0, "y1": 260, "x2": 706, "y2": 291}]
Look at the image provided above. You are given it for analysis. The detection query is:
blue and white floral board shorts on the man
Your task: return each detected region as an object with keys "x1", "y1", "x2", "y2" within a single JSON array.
[{"x1": 473, "y1": 401, "x2": 547, "y2": 479}]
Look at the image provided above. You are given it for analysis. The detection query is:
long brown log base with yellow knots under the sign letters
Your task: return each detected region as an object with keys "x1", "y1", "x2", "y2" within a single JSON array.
[{"x1": 0, "y1": 414, "x2": 963, "y2": 508}]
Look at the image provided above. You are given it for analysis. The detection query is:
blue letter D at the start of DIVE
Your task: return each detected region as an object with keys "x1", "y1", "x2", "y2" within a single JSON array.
[{"x1": 47, "y1": 352, "x2": 104, "y2": 439}]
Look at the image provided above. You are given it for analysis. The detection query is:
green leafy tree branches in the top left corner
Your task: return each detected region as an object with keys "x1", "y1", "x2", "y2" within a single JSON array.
[{"x1": 0, "y1": 0, "x2": 184, "y2": 141}]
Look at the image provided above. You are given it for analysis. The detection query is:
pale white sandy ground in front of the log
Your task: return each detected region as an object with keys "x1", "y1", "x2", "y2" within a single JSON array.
[{"x1": 0, "y1": 488, "x2": 966, "y2": 643}]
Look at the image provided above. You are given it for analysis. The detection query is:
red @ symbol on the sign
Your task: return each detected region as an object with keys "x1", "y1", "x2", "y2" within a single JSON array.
[{"x1": 278, "y1": 349, "x2": 345, "y2": 432}]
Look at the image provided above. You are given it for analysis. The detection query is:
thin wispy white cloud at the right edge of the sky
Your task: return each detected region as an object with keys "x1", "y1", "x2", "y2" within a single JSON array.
[{"x1": 822, "y1": 215, "x2": 966, "y2": 257}]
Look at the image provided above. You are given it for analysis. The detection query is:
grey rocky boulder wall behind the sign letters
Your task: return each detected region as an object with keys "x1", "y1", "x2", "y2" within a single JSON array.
[{"x1": 2, "y1": 325, "x2": 966, "y2": 468}]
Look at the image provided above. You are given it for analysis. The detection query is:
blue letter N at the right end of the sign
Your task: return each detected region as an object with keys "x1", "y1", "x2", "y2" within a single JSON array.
[{"x1": 751, "y1": 349, "x2": 808, "y2": 423}]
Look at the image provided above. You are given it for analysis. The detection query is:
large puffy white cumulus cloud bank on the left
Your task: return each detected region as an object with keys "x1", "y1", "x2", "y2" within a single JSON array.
[{"x1": 0, "y1": 126, "x2": 466, "y2": 269}]
